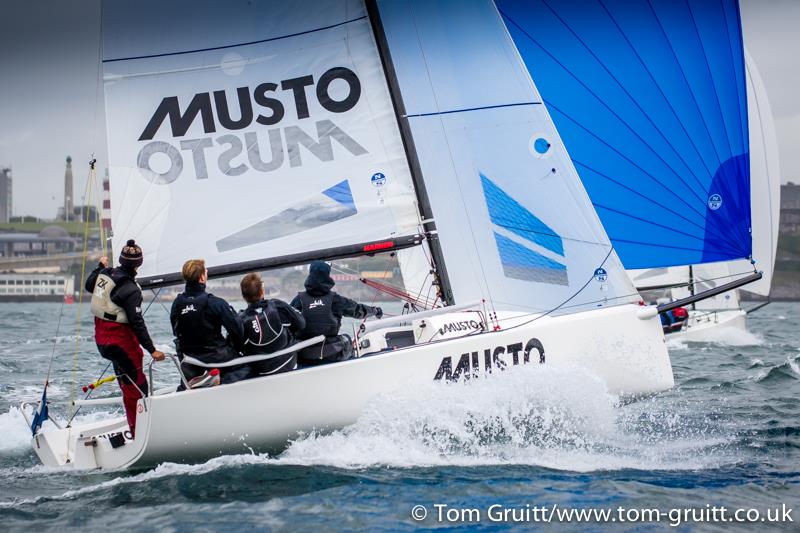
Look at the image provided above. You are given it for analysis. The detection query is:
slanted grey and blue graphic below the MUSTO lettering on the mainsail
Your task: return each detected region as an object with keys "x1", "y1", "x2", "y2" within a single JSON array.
[{"x1": 217, "y1": 180, "x2": 358, "y2": 252}]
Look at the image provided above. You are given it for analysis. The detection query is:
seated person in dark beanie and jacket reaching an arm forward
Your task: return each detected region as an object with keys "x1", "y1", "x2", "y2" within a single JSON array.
[{"x1": 291, "y1": 261, "x2": 383, "y2": 366}]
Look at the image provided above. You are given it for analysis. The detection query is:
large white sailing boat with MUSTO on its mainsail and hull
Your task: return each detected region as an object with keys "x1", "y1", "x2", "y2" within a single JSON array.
[{"x1": 26, "y1": 0, "x2": 749, "y2": 469}]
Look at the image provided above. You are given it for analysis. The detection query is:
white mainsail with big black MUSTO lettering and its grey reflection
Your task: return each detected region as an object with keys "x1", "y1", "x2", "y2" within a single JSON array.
[{"x1": 103, "y1": 0, "x2": 419, "y2": 276}]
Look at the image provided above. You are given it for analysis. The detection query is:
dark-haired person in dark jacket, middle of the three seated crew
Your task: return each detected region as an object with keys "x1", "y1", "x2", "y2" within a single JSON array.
[{"x1": 239, "y1": 273, "x2": 306, "y2": 377}]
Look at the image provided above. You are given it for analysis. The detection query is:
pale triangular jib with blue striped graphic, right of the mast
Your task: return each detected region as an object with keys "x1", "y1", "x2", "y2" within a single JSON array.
[{"x1": 379, "y1": 1, "x2": 638, "y2": 312}]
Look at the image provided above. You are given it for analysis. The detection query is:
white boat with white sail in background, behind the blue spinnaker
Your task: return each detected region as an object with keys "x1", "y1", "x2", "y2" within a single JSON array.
[{"x1": 629, "y1": 49, "x2": 780, "y2": 341}]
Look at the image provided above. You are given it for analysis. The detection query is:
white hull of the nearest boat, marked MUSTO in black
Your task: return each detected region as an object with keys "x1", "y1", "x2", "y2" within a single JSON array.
[{"x1": 28, "y1": 305, "x2": 674, "y2": 469}]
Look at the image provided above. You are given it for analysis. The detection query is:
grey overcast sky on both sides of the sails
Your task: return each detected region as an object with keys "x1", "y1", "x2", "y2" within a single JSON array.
[{"x1": 0, "y1": 0, "x2": 800, "y2": 218}]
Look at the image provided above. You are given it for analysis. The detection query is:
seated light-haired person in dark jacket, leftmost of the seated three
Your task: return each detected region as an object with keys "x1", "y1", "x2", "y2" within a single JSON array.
[{"x1": 174, "y1": 259, "x2": 249, "y2": 384}]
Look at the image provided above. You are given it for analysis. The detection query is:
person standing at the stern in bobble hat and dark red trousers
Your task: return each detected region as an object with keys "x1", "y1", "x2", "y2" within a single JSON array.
[{"x1": 85, "y1": 239, "x2": 164, "y2": 436}]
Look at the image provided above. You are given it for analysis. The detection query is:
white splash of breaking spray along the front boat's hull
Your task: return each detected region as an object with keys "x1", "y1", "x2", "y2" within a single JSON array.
[{"x1": 278, "y1": 367, "x2": 734, "y2": 471}]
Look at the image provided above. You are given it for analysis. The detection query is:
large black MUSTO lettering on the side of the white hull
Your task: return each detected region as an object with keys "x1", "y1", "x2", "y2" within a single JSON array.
[{"x1": 433, "y1": 337, "x2": 545, "y2": 381}]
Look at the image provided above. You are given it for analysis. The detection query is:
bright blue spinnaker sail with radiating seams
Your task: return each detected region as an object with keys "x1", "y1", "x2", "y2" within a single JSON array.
[{"x1": 496, "y1": 0, "x2": 752, "y2": 268}]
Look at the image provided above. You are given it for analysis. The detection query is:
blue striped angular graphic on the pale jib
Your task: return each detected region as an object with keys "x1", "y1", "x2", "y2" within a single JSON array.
[{"x1": 481, "y1": 174, "x2": 569, "y2": 285}]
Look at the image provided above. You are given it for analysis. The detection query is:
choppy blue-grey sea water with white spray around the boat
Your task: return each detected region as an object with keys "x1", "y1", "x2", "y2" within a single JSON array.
[{"x1": 0, "y1": 303, "x2": 800, "y2": 531}]
